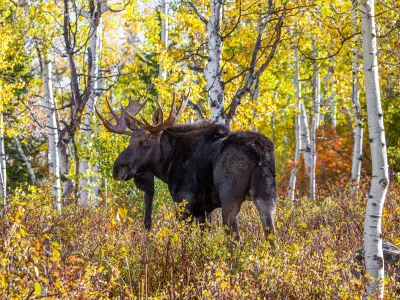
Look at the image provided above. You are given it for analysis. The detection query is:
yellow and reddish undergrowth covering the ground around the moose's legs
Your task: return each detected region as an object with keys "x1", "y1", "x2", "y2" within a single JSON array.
[{"x1": 0, "y1": 184, "x2": 400, "y2": 299}]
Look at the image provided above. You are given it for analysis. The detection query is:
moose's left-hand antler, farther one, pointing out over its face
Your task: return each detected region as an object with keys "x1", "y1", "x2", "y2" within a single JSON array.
[{"x1": 95, "y1": 97, "x2": 147, "y2": 135}]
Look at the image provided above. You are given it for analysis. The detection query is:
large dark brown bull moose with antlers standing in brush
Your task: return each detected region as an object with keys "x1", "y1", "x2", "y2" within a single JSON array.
[{"x1": 96, "y1": 93, "x2": 276, "y2": 239}]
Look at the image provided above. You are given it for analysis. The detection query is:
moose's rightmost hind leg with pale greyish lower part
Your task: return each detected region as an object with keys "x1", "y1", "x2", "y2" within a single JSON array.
[{"x1": 249, "y1": 169, "x2": 276, "y2": 240}]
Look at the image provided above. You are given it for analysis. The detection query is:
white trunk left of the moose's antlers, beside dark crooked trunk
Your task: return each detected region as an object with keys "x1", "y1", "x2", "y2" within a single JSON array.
[{"x1": 78, "y1": 3, "x2": 108, "y2": 206}]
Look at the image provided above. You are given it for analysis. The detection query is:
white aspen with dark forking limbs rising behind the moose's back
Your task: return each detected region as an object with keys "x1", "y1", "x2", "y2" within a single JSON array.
[{"x1": 188, "y1": 0, "x2": 287, "y2": 126}]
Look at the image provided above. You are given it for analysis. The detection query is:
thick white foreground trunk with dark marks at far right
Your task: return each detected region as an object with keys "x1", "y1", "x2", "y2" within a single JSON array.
[{"x1": 361, "y1": 0, "x2": 389, "y2": 299}]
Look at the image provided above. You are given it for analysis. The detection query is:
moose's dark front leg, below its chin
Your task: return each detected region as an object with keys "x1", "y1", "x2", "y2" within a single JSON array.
[{"x1": 135, "y1": 173, "x2": 154, "y2": 230}]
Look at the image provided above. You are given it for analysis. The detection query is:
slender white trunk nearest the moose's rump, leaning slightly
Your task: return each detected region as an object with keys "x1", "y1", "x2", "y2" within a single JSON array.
[{"x1": 288, "y1": 49, "x2": 301, "y2": 200}]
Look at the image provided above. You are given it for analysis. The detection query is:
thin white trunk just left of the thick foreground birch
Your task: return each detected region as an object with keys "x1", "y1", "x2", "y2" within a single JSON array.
[{"x1": 351, "y1": 0, "x2": 364, "y2": 196}]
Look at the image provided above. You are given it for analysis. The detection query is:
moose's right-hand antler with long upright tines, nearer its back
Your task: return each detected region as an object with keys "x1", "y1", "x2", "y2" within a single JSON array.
[{"x1": 126, "y1": 90, "x2": 190, "y2": 134}]
